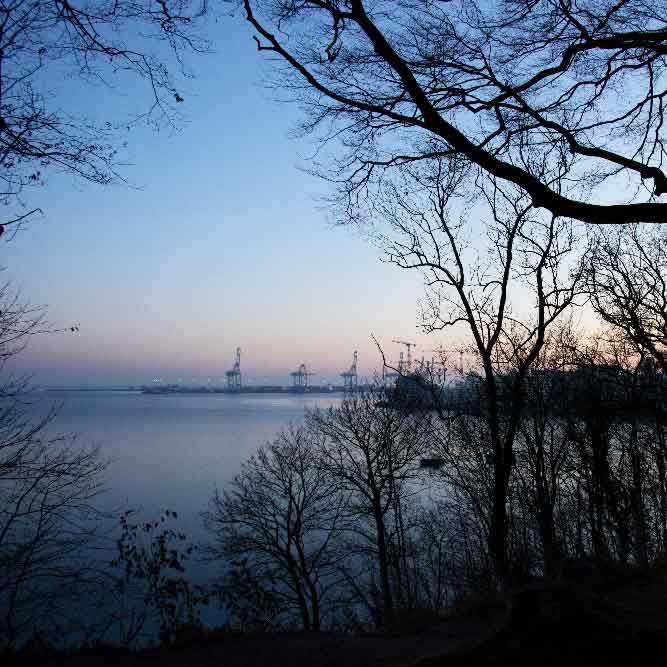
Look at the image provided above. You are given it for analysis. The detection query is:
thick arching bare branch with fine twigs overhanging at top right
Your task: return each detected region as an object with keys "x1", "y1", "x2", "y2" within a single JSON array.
[{"x1": 243, "y1": 0, "x2": 667, "y2": 224}]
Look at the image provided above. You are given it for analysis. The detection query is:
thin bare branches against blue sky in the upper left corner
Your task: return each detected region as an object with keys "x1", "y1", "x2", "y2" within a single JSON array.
[{"x1": 0, "y1": 0, "x2": 206, "y2": 231}]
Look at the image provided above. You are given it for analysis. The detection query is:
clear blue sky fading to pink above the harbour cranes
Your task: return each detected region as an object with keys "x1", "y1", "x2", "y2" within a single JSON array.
[{"x1": 0, "y1": 19, "x2": 438, "y2": 386}]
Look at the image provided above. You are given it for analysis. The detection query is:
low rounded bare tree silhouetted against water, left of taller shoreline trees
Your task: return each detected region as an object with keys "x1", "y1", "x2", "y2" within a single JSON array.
[{"x1": 203, "y1": 426, "x2": 345, "y2": 630}]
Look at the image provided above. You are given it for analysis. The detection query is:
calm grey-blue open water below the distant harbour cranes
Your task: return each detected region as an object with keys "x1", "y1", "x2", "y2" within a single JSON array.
[{"x1": 30, "y1": 391, "x2": 340, "y2": 538}]
